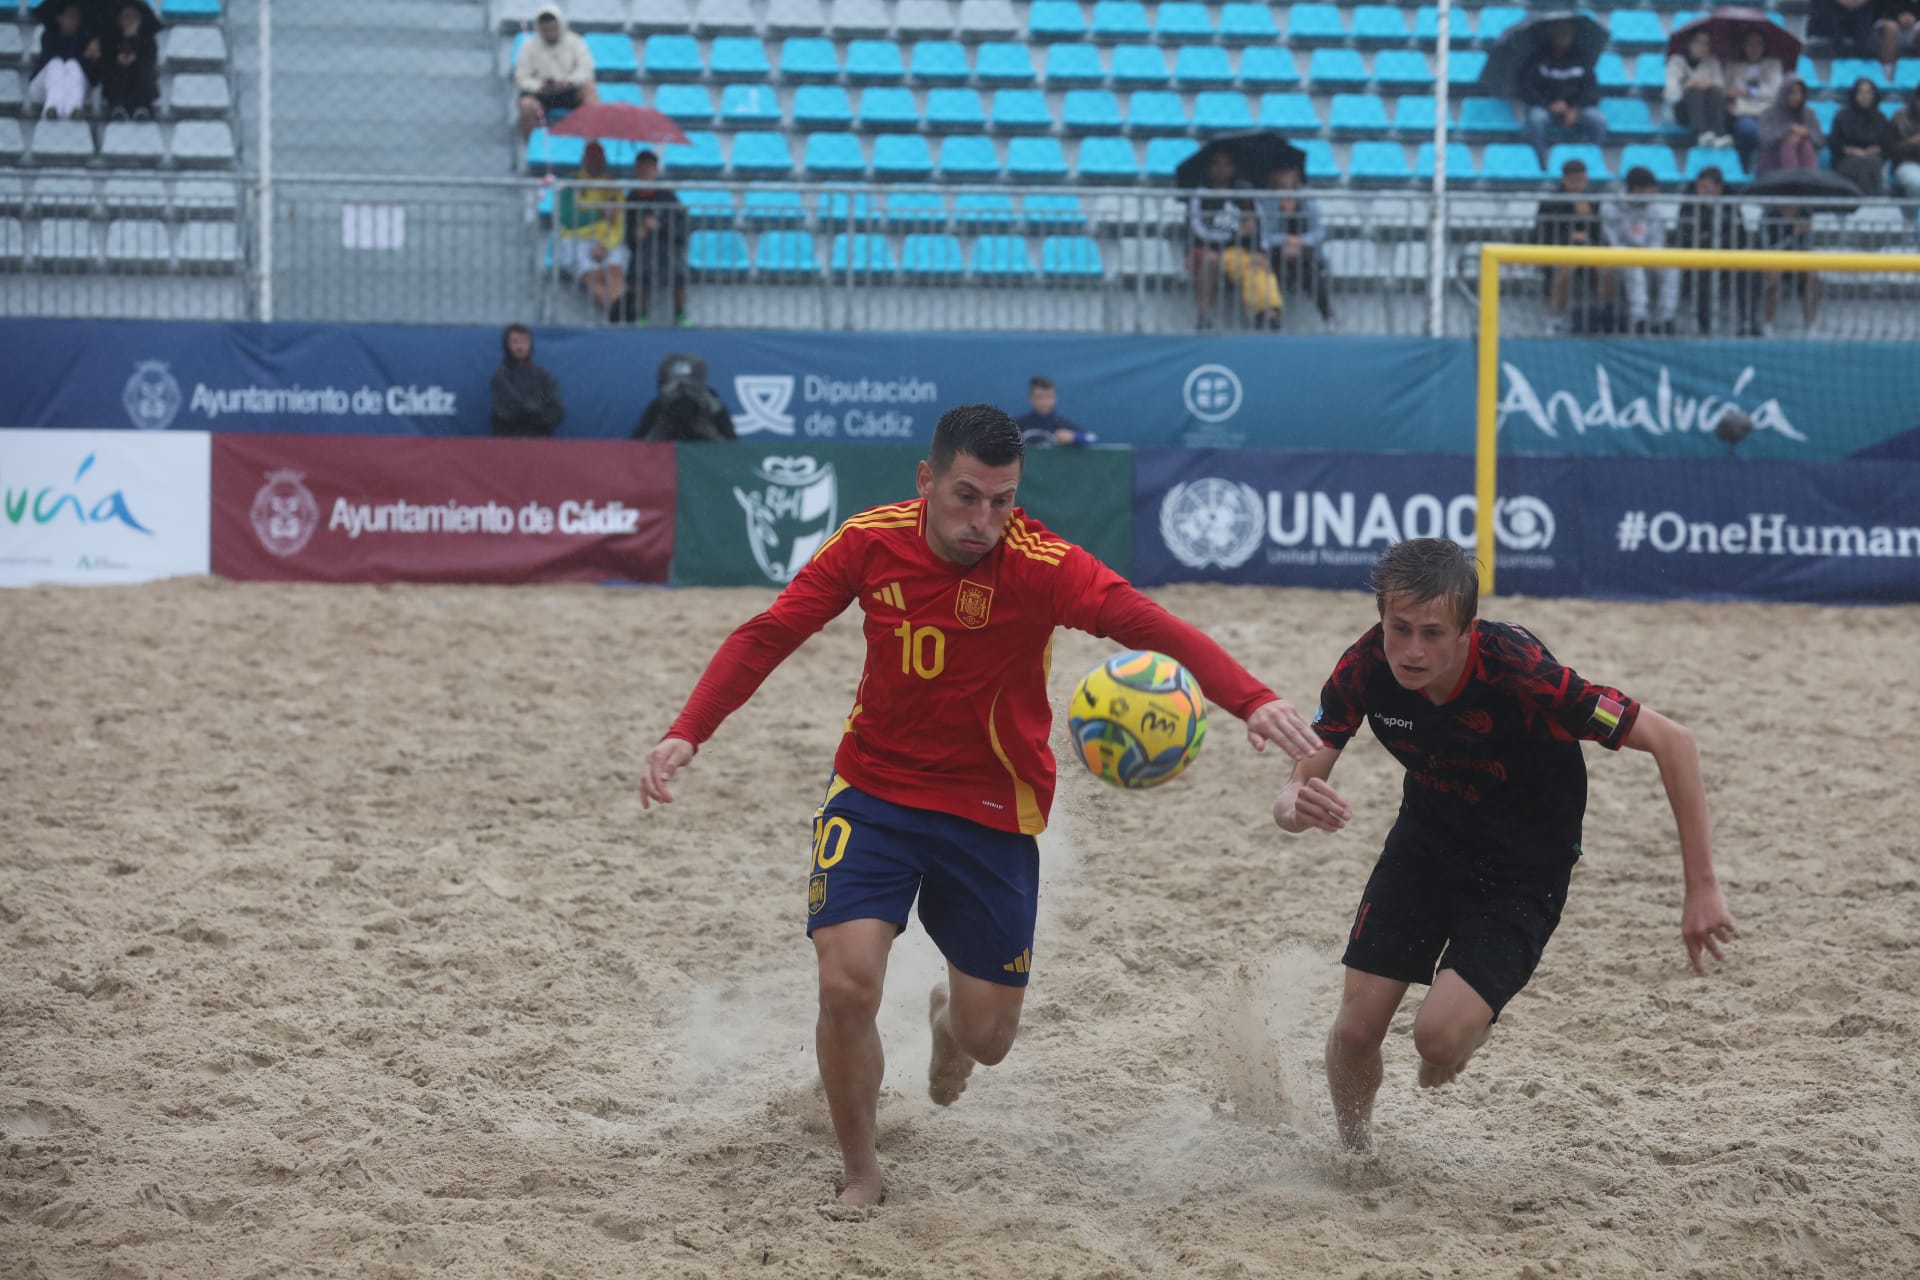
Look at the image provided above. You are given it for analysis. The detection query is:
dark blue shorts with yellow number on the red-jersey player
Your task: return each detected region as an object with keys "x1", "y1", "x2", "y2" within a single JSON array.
[{"x1": 806, "y1": 777, "x2": 1041, "y2": 986}]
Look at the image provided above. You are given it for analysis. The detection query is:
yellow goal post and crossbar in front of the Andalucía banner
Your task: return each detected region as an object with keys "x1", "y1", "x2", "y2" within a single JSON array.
[{"x1": 1473, "y1": 244, "x2": 1920, "y2": 597}]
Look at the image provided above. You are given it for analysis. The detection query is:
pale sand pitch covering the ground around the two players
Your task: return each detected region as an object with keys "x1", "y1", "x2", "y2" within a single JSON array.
[{"x1": 0, "y1": 581, "x2": 1920, "y2": 1280}]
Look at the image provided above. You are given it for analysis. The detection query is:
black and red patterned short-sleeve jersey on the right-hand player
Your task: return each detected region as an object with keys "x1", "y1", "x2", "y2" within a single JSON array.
[{"x1": 1313, "y1": 620, "x2": 1640, "y2": 865}]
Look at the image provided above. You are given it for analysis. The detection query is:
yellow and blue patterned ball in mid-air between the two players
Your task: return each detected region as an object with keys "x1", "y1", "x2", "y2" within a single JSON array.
[{"x1": 1068, "y1": 649, "x2": 1206, "y2": 791}]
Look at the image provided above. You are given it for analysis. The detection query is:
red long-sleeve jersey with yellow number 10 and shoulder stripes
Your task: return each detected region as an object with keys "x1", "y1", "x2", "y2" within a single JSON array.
[{"x1": 666, "y1": 499, "x2": 1275, "y2": 835}]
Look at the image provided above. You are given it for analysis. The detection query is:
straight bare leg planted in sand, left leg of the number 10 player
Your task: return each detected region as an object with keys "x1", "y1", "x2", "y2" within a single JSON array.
[{"x1": 814, "y1": 919, "x2": 897, "y2": 1207}]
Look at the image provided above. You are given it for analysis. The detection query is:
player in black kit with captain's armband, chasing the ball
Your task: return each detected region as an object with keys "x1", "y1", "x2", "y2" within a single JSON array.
[{"x1": 1273, "y1": 537, "x2": 1734, "y2": 1148}]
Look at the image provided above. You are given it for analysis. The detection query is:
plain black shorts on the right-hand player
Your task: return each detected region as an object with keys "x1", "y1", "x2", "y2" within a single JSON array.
[{"x1": 1340, "y1": 814, "x2": 1572, "y2": 1021}]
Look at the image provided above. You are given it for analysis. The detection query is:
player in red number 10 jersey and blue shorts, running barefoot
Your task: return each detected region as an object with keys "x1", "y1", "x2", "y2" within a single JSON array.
[{"x1": 639, "y1": 405, "x2": 1319, "y2": 1205}]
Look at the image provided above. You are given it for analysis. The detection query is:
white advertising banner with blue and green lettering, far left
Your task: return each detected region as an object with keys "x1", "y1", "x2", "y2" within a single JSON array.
[{"x1": 0, "y1": 430, "x2": 209, "y2": 587}]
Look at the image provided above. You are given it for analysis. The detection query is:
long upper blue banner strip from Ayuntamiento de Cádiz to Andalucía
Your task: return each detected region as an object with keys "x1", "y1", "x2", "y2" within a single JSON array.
[{"x1": 0, "y1": 320, "x2": 1920, "y2": 461}]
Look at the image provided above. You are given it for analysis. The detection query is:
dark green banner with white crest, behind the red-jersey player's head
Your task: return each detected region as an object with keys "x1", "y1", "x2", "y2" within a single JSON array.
[{"x1": 674, "y1": 443, "x2": 1133, "y2": 587}]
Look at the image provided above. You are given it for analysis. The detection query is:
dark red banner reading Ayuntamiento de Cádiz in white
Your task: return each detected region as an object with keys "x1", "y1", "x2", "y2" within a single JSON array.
[{"x1": 213, "y1": 432, "x2": 674, "y2": 583}]
